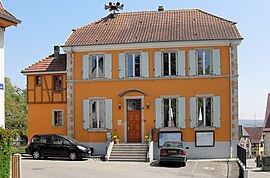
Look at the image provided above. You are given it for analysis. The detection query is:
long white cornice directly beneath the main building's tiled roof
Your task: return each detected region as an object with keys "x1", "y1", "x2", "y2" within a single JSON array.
[{"x1": 61, "y1": 39, "x2": 242, "y2": 52}]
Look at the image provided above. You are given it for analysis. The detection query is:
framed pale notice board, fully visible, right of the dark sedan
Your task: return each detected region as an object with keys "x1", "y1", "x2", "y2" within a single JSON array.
[{"x1": 195, "y1": 131, "x2": 215, "y2": 147}]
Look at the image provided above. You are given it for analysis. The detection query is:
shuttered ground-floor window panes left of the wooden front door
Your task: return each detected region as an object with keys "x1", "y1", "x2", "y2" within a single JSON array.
[{"x1": 90, "y1": 100, "x2": 106, "y2": 128}]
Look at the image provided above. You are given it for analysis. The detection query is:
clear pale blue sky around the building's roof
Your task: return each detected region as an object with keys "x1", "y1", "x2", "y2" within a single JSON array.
[{"x1": 2, "y1": 0, "x2": 270, "y2": 119}]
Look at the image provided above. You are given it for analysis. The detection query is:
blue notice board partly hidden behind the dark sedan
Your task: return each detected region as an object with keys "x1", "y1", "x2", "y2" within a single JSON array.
[{"x1": 158, "y1": 132, "x2": 182, "y2": 147}]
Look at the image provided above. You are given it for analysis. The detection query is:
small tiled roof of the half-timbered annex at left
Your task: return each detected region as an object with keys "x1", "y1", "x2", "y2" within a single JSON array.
[{"x1": 21, "y1": 54, "x2": 67, "y2": 74}]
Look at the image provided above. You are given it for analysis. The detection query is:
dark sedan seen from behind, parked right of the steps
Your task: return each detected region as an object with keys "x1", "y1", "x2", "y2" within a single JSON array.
[{"x1": 159, "y1": 141, "x2": 189, "y2": 166}]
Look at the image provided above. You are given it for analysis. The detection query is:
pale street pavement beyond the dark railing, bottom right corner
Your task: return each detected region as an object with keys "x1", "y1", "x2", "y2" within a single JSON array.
[{"x1": 247, "y1": 158, "x2": 270, "y2": 178}]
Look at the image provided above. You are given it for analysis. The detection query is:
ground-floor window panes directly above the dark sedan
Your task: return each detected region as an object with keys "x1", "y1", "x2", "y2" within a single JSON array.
[{"x1": 163, "y1": 98, "x2": 176, "y2": 127}]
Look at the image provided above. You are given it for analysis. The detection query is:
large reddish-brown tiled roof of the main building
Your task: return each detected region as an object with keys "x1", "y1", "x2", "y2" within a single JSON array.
[{"x1": 64, "y1": 9, "x2": 242, "y2": 46}]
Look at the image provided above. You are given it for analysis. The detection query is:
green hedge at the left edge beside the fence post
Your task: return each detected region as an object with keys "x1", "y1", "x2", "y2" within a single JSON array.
[{"x1": 0, "y1": 128, "x2": 13, "y2": 178}]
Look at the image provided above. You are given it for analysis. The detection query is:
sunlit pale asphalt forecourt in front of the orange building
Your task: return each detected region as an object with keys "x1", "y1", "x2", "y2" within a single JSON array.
[{"x1": 22, "y1": 158, "x2": 238, "y2": 178}]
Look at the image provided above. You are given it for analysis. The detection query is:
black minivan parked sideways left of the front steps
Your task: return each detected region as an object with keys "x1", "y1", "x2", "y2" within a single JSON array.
[{"x1": 25, "y1": 134, "x2": 94, "y2": 160}]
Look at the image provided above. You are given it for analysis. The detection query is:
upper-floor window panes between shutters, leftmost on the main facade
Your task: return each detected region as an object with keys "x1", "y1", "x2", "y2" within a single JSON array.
[{"x1": 89, "y1": 55, "x2": 105, "y2": 78}]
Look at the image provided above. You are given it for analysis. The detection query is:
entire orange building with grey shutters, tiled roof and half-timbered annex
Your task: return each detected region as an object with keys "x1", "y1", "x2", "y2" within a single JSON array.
[{"x1": 22, "y1": 9, "x2": 242, "y2": 158}]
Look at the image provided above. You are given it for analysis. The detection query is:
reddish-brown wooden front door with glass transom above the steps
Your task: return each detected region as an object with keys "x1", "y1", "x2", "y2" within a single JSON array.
[{"x1": 127, "y1": 99, "x2": 142, "y2": 143}]
